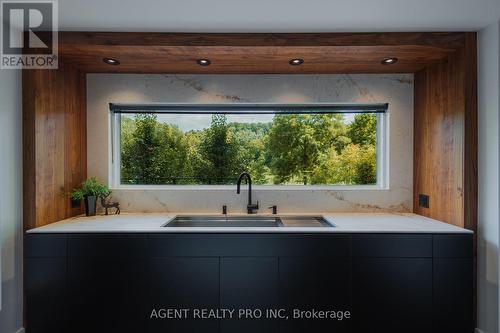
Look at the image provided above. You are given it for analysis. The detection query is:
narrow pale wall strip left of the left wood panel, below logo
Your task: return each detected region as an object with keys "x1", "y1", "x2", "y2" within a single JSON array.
[{"x1": 0, "y1": 70, "x2": 23, "y2": 333}]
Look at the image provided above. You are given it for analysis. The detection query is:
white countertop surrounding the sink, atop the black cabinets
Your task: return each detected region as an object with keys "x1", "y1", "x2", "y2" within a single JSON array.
[{"x1": 28, "y1": 213, "x2": 472, "y2": 233}]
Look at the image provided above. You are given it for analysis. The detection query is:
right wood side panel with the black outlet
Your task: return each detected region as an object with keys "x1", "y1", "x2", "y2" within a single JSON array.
[{"x1": 413, "y1": 33, "x2": 477, "y2": 231}]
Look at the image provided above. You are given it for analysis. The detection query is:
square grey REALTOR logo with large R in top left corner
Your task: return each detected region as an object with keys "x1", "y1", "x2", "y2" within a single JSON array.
[{"x1": 0, "y1": 0, "x2": 58, "y2": 69}]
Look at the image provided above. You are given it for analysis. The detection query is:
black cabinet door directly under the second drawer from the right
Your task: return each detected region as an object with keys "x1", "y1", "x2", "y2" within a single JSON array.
[{"x1": 353, "y1": 258, "x2": 432, "y2": 333}]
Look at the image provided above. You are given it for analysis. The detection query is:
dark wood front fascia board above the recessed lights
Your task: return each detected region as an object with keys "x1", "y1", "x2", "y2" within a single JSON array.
[{"x1": 59, "y1": 31, "x2": 464, "y2": 49}]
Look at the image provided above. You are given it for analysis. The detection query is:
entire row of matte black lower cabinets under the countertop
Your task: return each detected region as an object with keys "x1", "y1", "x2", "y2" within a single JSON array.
[{"x1": 26, "y1": 234, "x2": 473, "y2": 333}]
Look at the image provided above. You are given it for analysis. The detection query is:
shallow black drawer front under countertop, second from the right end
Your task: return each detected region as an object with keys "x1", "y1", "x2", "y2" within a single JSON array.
[{"x1": 352, "y1": 234, "x2": 432, "y2": 258}]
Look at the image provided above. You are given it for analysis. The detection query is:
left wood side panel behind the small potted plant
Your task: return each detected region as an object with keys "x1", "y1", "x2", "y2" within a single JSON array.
[{"x1": 23, "y1": 63, "x2": 87, "y2": 230}]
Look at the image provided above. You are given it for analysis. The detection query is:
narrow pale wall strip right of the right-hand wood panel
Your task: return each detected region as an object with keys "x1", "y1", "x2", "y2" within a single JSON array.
[{"x1": 477, "y1": 20, "x2": 500, "y2": 333}]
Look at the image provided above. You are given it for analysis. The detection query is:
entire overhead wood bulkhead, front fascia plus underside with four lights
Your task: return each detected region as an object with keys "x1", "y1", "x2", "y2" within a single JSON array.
[{"x1": 53, "y1": 32, "x2": 464, "y2": 74}]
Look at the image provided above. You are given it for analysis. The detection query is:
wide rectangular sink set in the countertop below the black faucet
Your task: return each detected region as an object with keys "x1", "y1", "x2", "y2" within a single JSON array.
[{"x1": 164, "y1": 215, "x2": 334, "y2": 228}]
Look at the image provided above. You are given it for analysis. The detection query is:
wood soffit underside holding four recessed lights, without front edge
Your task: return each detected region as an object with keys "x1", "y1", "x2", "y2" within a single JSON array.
[{"x1": 60, "y1": 45, "x2": 449, "y2": 74}]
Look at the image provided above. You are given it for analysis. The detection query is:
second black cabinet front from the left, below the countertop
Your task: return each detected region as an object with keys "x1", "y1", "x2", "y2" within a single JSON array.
[{"x1": 67, "y1": 234, "x2": 149, "y2": 333}]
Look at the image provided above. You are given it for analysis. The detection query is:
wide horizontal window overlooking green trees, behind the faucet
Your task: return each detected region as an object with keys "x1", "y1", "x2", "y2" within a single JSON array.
[{"x1": 111, "y1": 104, "x2": 387, "y2": 187}]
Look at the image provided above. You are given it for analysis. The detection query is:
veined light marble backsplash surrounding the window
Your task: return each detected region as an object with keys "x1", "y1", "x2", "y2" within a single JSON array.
[{"x1": 87, "y1": 74, "x2": 413, "y2": 213}]
